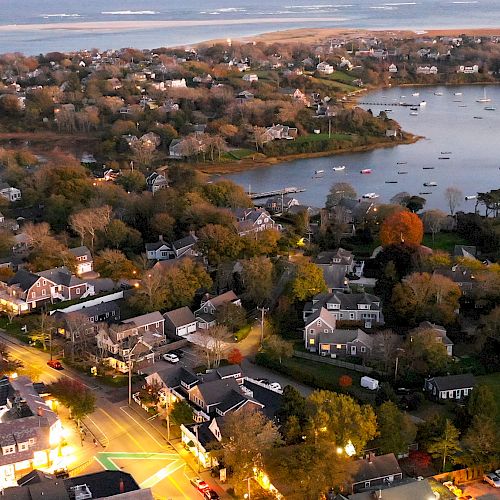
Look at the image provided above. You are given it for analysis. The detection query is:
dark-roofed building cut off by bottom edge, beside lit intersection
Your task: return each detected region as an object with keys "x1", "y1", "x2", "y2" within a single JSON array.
[{"x1": 2, "y1": 470, "x2": 153, "y2": 500}]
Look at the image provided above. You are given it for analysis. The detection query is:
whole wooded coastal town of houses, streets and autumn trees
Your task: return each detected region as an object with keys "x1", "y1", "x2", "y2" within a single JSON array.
[{"x1": 0, "y1": 26, "x2": 500, "y2": 500}]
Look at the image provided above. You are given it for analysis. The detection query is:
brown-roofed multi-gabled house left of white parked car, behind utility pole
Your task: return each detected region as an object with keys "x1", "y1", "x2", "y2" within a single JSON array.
[{"x1": 96, "y1": 311, "x2": 166, "y2": 373}]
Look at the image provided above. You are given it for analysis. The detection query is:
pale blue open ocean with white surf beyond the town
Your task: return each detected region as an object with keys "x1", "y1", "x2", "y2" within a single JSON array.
[{"x1": 0, "y1": 0, "x2": 500, "y2": 54}]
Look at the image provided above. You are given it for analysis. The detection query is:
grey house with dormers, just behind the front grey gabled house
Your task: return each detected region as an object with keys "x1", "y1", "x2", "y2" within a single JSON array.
[{"x1": 303, "y1": 292, "x2": 384, "y2": 328}]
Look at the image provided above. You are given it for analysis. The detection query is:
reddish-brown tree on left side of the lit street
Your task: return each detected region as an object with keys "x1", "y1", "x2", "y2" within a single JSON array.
[{"x1": 47, "y1": 377, "x2": 96, "y2": 427}]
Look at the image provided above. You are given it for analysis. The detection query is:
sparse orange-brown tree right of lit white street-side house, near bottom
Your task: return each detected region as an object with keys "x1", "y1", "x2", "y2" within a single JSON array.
[{"x1": 220, "y1": 406, "x2": 280, "y2": 493}]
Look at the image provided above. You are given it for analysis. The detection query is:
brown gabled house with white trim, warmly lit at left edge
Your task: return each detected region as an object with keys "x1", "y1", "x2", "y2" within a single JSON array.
[{"x1": 0, "y1": 267, "x2": 94, "y2": 314}]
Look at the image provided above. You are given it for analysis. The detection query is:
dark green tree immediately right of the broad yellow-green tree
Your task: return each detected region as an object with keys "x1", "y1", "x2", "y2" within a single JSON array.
[{"x1": 377, "y1": 401, "x2": 417, "y2": 456}]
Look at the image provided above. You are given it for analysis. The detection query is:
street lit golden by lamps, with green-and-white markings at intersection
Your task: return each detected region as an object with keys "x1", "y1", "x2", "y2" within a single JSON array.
[{"x1": 0, "y1": 331, "x2": 221, "y2": 500}]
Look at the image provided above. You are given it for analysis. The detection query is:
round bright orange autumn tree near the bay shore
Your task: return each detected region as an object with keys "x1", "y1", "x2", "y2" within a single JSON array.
[{"x1": 380, "y1": 211, "x2": 424, "y2": 247}]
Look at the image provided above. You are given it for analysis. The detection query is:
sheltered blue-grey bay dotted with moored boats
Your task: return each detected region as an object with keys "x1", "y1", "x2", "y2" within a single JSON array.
[{"x1": 227, "y1": 86, "x2": 500, "y2": 211}]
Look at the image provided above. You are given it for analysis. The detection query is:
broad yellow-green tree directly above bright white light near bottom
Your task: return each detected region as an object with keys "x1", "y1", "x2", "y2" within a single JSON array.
[{"x1": 306, "y1": 391, "x2": 377, "y2": 452}]
